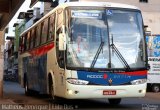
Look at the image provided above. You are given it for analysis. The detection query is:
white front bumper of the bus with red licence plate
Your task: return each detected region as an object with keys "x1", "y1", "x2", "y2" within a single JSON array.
[{"x1": 65, "y1": 83, "x2": 147, "y2": 99}]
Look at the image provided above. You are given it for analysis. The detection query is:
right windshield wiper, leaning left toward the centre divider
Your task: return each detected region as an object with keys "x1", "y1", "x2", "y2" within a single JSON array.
[{"x1": 110, "y1": 36, "x2": 131, "y2": 70}]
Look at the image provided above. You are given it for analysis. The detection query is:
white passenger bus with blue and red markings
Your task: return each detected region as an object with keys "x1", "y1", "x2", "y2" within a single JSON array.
[{"x1": 19, "y1": 2, "x2": 147, "y2": 104}]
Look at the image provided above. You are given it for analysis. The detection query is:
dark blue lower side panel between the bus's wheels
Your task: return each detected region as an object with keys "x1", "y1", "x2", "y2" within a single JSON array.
[{"x1": 23, "y1": 54, "x2": 47, "y2": 93}]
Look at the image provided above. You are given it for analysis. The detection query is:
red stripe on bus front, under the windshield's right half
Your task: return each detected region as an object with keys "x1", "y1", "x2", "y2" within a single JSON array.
[{"x1": 119, "y1": 70, "x2": 147, "y2": 76}]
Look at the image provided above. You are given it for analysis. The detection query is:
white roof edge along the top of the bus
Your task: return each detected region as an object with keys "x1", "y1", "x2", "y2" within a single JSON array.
[{"x1": 20, "y1": 1, "x2": 139, "y2": 36}]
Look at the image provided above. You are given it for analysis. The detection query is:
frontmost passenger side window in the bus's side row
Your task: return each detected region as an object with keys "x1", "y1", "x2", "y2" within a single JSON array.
[{"x1": 47, "y1": 14, "x2": 55, "y2": 41}]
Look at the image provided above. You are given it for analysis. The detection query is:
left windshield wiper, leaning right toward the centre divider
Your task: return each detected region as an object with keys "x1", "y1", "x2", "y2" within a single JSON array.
[{"x1": 90, "y1": 41, "x2": 104, "y2": 69}]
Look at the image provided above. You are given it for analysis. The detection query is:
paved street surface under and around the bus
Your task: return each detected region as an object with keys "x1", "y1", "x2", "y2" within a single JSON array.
[{"x1": 1, "y1": 81, "x2": 160, "y2": 110}]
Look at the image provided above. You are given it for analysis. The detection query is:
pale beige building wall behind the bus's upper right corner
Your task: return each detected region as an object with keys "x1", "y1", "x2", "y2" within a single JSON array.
[{"x1": 83, "y1": 0, "x2": 160, "y2": 34}]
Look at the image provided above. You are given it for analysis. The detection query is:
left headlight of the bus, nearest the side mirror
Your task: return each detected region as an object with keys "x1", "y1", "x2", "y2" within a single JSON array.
[{"x1": 67, "y1": 78, "x2": 89, "y2": 85}]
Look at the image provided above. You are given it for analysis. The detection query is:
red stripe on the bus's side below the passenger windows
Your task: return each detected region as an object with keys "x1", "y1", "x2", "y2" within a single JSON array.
[{"x1": 29, "y1": 43, "x2": 54, "y2": 56}]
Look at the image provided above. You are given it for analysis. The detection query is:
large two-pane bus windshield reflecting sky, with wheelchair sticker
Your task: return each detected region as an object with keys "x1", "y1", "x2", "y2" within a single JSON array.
[{"x1": 67, "y1": 8, "x2": 145, "y2": 69}]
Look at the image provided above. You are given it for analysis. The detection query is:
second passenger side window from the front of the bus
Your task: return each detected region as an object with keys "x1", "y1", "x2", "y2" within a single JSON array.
[{"x1": 41, "y1": 18, "x2": 48, "y2": 44}]
